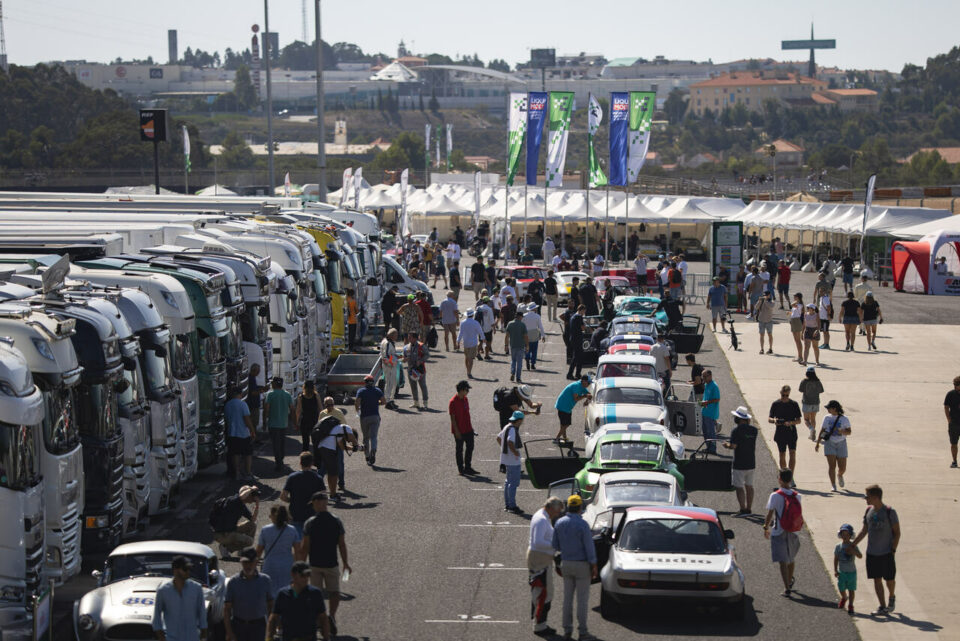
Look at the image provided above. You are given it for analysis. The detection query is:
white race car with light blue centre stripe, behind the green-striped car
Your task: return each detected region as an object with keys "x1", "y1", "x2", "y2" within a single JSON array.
[{"x1": 583, "y1": 376, "x2": 669, "y2": 435}]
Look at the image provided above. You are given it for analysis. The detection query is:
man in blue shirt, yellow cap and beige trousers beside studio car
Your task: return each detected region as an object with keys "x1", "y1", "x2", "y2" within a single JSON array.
[{"x1": 553, "y1": 494, "x2": 598, "y2": 639}]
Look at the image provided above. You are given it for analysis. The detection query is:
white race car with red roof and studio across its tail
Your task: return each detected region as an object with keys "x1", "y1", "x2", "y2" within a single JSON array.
[{"x1": 594, "y1": 506, "x2": 746, "y2": 619}]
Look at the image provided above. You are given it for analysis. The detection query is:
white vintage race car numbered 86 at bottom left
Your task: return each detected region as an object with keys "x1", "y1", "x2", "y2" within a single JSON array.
[{"x1": 73, "y1": 541, "x2": 227, "y2": 641}]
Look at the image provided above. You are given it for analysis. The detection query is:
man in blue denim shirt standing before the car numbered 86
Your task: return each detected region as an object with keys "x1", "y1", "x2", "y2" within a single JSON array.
[{"x1": 151, "y1": 555, "x2": 207, "y2": 641}]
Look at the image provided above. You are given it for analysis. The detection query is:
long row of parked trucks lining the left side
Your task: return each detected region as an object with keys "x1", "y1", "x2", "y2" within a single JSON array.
[{"x1": 0, "y1": 194, "x2": 427, "y2": 641}]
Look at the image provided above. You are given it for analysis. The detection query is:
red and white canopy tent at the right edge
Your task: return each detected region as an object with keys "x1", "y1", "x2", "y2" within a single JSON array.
[{"x1": 892, "y1": 230, "x2": 960, "y2": 296}]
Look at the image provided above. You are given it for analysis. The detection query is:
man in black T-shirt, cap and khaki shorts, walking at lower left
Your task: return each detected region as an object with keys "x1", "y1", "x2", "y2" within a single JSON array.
[{"x1": 301, "y1": 492, "x2": 353, "y2": 634}]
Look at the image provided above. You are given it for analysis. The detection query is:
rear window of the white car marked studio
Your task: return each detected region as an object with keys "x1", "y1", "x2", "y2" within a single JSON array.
[{"x1": 617, "y1": 519, "x2": 726, "y2": 554}]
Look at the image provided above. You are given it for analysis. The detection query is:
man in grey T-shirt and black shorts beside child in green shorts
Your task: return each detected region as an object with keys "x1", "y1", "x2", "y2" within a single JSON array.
[{"x1": 853, "y1": 485, "x2": 900, "y2": 616}]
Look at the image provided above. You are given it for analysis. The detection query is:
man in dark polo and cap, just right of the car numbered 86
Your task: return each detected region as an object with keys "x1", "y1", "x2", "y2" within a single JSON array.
[{"x1": 223, "y1": 548, "x2": 272, "y2": 641}]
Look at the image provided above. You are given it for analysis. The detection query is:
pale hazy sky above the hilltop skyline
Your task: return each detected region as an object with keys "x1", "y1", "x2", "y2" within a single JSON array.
[{"x1": 3, "y1": 0, "x2": 960, "y2": 71}]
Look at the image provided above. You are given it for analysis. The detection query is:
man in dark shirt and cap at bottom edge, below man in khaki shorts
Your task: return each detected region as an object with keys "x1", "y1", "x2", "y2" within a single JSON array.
[{"x1": 266, "y1": 561, "x2": 331, "y2": 641}]
